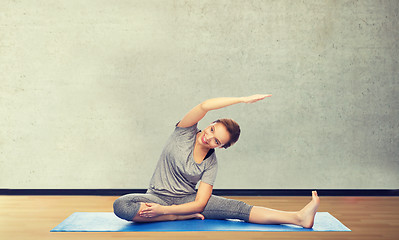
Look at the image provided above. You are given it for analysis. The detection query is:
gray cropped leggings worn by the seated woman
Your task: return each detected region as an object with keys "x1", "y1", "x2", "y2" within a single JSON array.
[{"x1": 114, "y1": 192, "x2": 252, "y2": 222}]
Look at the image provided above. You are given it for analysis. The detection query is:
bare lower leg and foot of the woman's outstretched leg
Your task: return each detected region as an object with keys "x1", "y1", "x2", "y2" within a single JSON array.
[{"x1": 249, "y1": 191, "x2": 320, "y2": 228}]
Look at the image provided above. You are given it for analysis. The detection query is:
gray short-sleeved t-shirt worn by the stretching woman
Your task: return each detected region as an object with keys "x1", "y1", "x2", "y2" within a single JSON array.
[{"x1": 149, "y1": 124, "x2": 217, "y2": 197}]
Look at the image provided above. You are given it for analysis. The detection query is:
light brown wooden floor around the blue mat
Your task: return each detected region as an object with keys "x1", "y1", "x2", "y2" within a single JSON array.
[{"x1": 0, "y1": 196, "x2": 399, "y2": 240}]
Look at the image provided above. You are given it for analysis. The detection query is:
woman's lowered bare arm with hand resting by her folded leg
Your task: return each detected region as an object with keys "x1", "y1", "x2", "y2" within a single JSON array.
[{"x1": 139, "y1": 182, "x2": 213, "y2": 217}]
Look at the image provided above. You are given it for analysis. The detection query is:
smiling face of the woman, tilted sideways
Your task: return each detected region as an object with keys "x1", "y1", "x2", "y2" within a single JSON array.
[{"x1": 197, "y1": 123, "x2": 230, "y2": 148}]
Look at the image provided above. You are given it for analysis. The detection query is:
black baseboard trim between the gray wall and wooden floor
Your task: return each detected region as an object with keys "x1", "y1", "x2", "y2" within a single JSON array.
[{"x1": 0, "y1": 188, "x2": 399, "y2": 196}]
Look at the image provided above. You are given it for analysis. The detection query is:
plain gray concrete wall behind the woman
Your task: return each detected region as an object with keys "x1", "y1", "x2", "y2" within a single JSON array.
[{"x1": 0, "y1": 0, "x2": 399, "y2": 189}]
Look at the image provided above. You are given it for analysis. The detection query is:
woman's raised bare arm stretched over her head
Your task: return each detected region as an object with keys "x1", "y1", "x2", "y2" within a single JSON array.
[{"x1": 177, "y1": 94, "x2": 272, "y2": 128}]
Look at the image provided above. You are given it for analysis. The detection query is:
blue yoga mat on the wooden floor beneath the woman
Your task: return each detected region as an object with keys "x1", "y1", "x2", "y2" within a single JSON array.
[{"x1": 50, "y1": 212, "x2": 351, "y2": 232}]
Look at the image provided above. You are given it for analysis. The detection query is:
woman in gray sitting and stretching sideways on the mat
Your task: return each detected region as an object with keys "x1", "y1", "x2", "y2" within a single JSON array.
[{"x1": 114, "y1": 95, "x2": 320, "y2": 228}]
